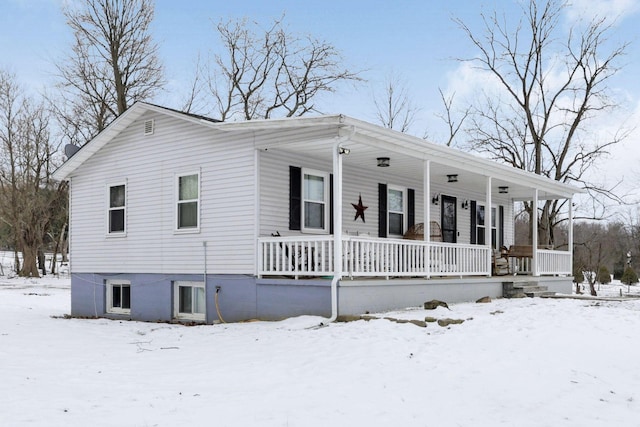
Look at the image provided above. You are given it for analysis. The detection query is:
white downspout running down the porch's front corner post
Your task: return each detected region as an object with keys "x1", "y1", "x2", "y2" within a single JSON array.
[{"x1": 327, "y1": 126, "x2": 355, "y2": 322}]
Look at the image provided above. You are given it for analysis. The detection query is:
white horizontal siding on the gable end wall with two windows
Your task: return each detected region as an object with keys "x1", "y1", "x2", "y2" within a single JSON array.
[{"x1": 65, "y1": 113, "x2": 256, "y2": 274}]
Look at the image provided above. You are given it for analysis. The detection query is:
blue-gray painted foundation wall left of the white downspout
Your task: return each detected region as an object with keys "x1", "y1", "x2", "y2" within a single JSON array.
[{"x1": 71, "y1": 273, "x2": 331, "y2": 323}]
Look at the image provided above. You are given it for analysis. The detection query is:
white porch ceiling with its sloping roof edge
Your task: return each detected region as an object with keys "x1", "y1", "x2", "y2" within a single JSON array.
[{"x1": 252, "y1": 118, "x2": 580, "y2": 200}]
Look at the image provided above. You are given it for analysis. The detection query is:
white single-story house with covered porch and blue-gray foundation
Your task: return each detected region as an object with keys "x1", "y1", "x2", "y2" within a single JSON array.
[{"x1": 55, "y1": 102, "x2": 579, "y2": 323}]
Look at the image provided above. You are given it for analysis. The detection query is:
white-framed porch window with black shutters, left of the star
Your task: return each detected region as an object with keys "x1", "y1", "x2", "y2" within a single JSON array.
[{"x1": 302, "y1": 170, "x2": 329, "y2": 232}]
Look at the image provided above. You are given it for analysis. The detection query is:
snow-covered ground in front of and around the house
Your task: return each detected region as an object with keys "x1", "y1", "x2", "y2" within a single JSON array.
[{"x1": 0, "y1": 277, "x2": 640, "y2": 427}]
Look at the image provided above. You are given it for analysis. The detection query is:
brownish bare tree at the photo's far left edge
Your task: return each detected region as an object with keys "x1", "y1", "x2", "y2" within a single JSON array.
[{"x1": 0, "y1": 70, "x2": 66, "y2": 277}]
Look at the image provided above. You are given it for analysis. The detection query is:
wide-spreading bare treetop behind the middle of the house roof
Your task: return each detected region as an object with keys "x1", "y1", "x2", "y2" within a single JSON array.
[{"x1": 192, "y1": 19, "x2": 361, "y2": 121}]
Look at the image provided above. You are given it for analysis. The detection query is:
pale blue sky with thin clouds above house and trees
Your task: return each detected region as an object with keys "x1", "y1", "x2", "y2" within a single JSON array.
[{"x1": 0, "y1": 0, "x2": 640, "y2": 204}]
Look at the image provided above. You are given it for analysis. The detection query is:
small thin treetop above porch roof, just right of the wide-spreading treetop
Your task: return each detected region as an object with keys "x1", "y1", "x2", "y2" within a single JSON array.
[{"x1": 373, "y1": 72, "x2": 420, "y2": 133}]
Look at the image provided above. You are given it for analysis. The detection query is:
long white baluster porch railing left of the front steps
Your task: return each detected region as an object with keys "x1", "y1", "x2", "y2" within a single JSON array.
[{"x1": 258, "y1": 236, "x2": 491, "y2": 278}]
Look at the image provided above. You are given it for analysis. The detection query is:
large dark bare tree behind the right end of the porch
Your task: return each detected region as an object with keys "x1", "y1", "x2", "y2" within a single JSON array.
[{"x1": 457, "y1": 0, "x2": 627, "y2": 244}]
